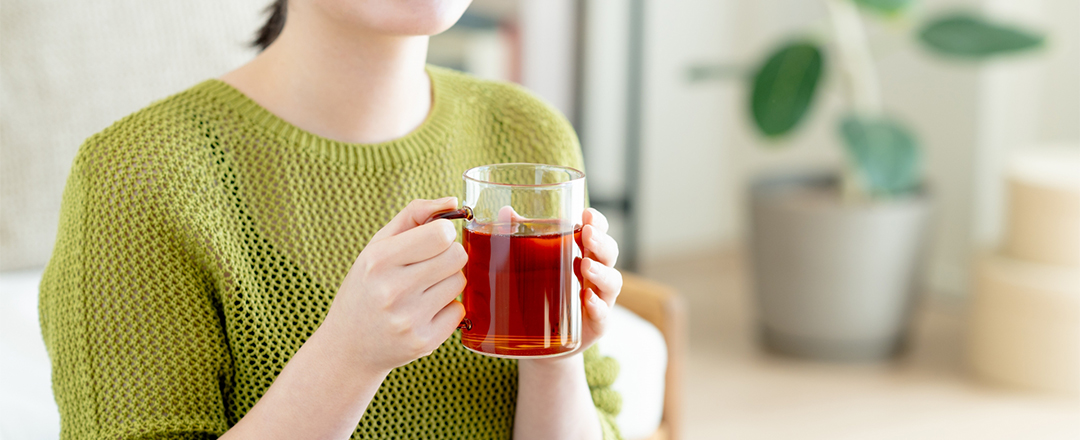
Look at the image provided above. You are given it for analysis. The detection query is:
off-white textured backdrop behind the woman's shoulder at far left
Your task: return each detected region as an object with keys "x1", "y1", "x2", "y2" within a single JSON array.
[{"x1": 0, "y1": 0, "x2": 269, "y2": 270}]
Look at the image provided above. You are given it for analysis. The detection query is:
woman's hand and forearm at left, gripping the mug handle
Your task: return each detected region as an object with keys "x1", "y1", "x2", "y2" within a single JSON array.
[{"x1": 221, "y1": 198, "x2": 468, "y2": 440}]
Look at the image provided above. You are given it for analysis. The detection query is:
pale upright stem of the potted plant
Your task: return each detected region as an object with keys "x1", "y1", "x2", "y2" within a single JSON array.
[{"x1": 825, "y1": 0, "x2": 882, "y2": 202}]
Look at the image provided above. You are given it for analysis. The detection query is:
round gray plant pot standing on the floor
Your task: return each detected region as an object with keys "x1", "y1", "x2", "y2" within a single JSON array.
[{"x1": 750, "y1": 174, "x2": 929, "y2": 360}]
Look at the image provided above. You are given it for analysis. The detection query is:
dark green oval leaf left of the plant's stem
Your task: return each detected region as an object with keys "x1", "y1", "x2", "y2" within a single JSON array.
[{"x1": 751, "y1": 43, "x2": 822, "y2": 136}]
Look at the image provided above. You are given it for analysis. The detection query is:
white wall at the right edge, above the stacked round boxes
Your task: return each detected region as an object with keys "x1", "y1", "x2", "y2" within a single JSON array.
[{"x1": 974, "y1": 0, "x2": 1080, "y2": 251}]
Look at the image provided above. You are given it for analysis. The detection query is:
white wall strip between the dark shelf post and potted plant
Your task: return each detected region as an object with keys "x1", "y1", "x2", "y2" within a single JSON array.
[{"x1": 640, "y1": 0, "x2": 734, "y2": 261}]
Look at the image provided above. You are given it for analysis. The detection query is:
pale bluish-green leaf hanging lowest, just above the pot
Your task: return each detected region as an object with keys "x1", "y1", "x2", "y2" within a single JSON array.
[{"x1": 840, "y1": 115, "x2": 921, "y2": 196}]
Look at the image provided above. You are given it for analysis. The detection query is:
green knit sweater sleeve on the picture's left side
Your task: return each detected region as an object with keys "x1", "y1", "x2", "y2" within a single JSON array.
[{"x1": 40, "y1": 135, "x2": 230, "y2": 439}]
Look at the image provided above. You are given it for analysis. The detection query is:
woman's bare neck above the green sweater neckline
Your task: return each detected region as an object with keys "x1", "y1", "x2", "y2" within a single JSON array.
[{"x1": 221, "y1": 4, "x2": 432, "y2": 144}]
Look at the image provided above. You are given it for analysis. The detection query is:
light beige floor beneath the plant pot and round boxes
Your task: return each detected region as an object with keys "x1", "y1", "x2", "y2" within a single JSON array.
[{"x1": 643, "y1": 252, "x2": 1080, "y2": 440}]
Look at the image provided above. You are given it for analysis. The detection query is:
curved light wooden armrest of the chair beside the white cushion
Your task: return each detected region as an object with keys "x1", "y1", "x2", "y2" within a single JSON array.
[{"x1": 618, "y1": 272, "x2": 688, "y2": 440}]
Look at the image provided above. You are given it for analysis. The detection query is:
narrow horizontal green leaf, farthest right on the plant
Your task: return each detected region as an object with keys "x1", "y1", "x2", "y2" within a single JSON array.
[{"x1": 919, "y1": 13, "x2": 1045, "y2": 58}]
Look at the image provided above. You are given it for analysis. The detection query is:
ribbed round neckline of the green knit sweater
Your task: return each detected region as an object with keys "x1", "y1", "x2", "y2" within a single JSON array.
[{"x1": 201, "y1": 66, "x2": 453, "y2": 168}]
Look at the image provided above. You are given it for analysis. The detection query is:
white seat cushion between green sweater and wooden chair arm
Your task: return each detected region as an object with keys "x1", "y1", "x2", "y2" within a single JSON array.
[{"x1": 597, "y1": 305, "x2": 667, "y2": 440}]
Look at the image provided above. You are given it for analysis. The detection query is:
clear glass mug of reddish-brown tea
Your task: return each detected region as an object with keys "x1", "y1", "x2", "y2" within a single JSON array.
[{"x1": 428, "y1": 163, "x2": 585, "y2": 359}]
